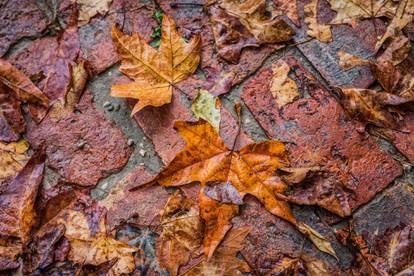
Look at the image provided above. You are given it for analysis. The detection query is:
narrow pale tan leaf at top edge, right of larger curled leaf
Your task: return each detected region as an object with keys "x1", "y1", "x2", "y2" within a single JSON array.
[{"x1": 304, "y1": 0, "x2": 332, "y2": 43}]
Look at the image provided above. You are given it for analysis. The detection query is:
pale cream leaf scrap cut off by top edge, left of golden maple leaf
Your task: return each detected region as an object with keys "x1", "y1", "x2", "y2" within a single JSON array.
[{"x1": 76, "y1": 0, "x2": 112, "y2": 26}]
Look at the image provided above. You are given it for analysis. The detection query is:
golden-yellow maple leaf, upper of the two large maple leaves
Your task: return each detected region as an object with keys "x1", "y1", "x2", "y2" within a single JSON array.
[{"x1": 111, "y1": 15, "x2": 201, "y2": 114}]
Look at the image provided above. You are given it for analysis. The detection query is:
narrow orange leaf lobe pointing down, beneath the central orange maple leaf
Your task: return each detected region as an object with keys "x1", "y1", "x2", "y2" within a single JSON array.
[{"x1": 199, "y1": 190, "x2": 239, "y2": 260}]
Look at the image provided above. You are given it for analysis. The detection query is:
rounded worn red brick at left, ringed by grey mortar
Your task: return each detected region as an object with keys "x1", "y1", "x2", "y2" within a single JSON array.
[{"x1": 27, "y1": 92, "x2": 132, "y2": 186}]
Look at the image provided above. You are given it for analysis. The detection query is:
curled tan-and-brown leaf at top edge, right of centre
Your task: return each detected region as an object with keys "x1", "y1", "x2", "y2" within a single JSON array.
[{"x1": 220, "y1": 0, "x2": 294, "y2": 44}]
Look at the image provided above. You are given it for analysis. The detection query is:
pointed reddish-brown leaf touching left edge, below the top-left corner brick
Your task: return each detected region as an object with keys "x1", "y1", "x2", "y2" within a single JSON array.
[{"x1": 0, "y1": 59, "x2": 49, "y2": 106}]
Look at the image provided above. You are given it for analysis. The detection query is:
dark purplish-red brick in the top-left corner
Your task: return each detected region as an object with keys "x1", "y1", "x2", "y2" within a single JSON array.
[{"x1": 0, "y1": 0, "x2": 51, "y2": 56}]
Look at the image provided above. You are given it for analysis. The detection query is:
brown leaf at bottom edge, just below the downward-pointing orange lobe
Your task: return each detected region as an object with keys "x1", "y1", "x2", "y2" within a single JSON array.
[{"x1": 182, "y1": 228, "x2": 250, "y2": 276}]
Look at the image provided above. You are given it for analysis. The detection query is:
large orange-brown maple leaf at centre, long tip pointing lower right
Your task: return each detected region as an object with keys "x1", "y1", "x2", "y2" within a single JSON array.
[{"x1": 139, "y1": 120, "x2": 336, "y2": 256}]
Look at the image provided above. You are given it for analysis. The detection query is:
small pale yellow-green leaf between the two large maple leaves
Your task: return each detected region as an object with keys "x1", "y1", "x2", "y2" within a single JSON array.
[{"x1": 191, "y1": 89, "x2": 221, "y2": 131}]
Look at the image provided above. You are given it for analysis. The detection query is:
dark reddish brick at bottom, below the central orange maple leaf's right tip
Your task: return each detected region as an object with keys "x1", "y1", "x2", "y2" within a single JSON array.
[{"x1": 232, "y1": 196, "x2": 341, "y2": 275}]
